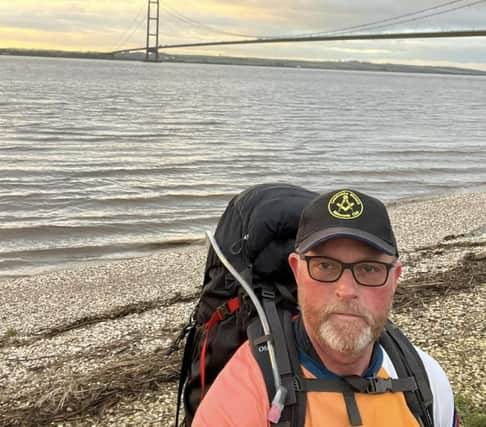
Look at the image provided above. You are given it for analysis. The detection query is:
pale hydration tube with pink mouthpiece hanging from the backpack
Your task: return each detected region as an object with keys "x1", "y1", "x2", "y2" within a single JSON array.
[{"x1": 206, "y1": 231, "x2": 287, "y2": 424}]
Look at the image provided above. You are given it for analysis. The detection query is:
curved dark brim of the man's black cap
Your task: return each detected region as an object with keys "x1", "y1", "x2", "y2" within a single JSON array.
[{"x1": 296, "y1": 227, "x2": 398, "y2": 256}]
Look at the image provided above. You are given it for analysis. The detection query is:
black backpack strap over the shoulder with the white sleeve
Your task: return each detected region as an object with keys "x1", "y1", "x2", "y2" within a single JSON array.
[{"x1": 380, "y1": 321, "x2": 434, "y2": 427}]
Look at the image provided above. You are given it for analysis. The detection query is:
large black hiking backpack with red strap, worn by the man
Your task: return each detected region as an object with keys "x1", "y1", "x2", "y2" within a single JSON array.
[{"x1": 176, "y1": 184, "x2": 433, "y2": 427}]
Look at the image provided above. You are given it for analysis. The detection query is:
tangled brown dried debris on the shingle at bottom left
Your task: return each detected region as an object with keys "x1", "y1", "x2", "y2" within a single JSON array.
[{"x1": 0, "y1": 349, "x2": 180, "y2": 426}]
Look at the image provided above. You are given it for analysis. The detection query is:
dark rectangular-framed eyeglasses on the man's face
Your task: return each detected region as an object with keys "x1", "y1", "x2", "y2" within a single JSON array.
[{"x1": 300, "y1": 255, "x2": 395, "y2": 287}]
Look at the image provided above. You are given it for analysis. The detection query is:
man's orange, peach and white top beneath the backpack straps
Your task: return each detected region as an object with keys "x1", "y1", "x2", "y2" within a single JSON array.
[{"x1": 192, "y1": 342, "x2": 454, "y2": 427}]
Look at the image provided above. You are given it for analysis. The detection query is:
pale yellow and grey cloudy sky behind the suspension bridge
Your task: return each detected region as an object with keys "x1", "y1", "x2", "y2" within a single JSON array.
[{"x1": 0, "y1": 0, "x2": 486, "y2": 70}]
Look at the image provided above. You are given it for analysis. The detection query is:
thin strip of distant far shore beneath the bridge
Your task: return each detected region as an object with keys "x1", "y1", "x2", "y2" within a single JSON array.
[{"x1": 0, "y1": 48, "x2": 486, "y2": 76}]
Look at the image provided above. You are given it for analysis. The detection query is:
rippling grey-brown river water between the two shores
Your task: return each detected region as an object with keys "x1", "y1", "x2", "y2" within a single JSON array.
[{"x1": 0, "y1": 56, "x2": 486, "y2": 277}]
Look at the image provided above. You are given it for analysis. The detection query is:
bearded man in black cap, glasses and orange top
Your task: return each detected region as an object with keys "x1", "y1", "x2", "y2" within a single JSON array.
[{"x1": 193, "y1": 190, "x2": 457, "y2": 427}]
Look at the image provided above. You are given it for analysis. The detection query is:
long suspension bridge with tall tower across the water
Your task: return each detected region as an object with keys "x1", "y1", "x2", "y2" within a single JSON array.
[{"x1": 110, "y1": 0, "x2": 486, "y2": 62}]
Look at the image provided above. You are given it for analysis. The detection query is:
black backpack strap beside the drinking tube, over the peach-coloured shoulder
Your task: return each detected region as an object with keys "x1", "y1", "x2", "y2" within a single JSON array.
[{"x1": 247, "y1": 297, "x2": 306, "y2": 427}]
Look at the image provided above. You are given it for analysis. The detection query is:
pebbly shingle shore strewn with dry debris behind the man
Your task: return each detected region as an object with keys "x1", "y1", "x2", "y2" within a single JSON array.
[{"x1": 0, "y1": 193, "x2": 486, "y2": 426}]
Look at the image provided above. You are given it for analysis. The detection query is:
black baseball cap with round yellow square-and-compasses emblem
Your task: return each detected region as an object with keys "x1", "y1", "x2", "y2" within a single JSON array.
[{"x1": 295, "y1": 189, "x2": 398, "y2": 257}]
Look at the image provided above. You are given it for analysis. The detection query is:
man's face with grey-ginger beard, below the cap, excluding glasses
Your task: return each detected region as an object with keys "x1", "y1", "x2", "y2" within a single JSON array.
[{"x1": 289, "y1": 238, "x2": 401, "y2": 354}]
